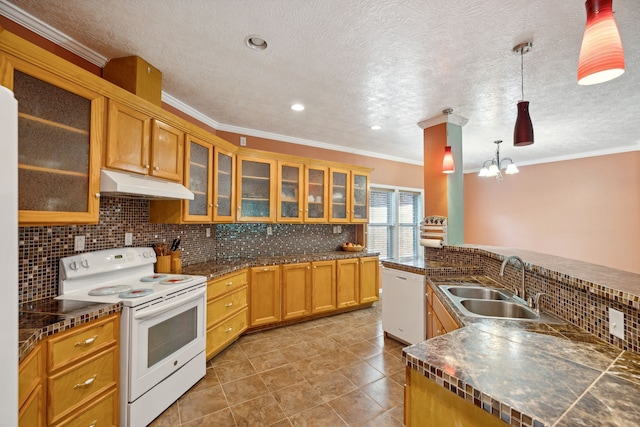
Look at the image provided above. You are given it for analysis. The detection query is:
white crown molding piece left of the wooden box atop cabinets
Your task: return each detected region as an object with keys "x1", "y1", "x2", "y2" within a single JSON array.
[{"x1": 0, "y1": 0, "x2": 108, "y2": 68}]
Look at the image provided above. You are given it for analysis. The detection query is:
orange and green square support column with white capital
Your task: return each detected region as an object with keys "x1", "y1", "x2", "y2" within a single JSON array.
[{"x1": 418, "y1": 110, "x2": 468, "y2": 245}]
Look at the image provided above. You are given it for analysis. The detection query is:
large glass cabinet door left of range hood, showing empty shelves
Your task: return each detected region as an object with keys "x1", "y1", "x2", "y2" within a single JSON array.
[{"x1": 13, "y1": 70, "x2": 105, "y2": 224}]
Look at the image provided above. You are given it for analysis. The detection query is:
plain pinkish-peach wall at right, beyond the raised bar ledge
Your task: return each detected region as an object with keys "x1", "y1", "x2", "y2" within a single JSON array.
[{"x1": 464, "y1": 151, "x2": 640, "y2": 273}]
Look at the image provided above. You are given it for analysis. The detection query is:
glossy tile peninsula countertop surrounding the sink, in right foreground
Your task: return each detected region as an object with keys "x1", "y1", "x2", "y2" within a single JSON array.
[{"x1": 383, "y1": 260, "x2": 640, "y2": 427}]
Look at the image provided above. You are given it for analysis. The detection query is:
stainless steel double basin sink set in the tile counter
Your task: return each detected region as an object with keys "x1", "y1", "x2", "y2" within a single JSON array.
[{"x1": 440, "y1": 285, "x2": 559, "y2": 323}]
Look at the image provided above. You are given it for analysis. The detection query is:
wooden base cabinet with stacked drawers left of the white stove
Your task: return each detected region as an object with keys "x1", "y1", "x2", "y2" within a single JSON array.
[{"x1": 18, "y1": 314, "x2": 120, "y2": 427}]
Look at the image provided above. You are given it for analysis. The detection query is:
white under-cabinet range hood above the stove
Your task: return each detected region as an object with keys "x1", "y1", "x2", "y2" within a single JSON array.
[{"x1": 100, "y1": 169, "x2": 193, "y2": 200}]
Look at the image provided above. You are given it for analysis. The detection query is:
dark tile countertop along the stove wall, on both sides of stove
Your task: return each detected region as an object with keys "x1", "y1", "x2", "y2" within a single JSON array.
[{"x1": 18, "y1": 251, "x2": 378, "y2": 361}]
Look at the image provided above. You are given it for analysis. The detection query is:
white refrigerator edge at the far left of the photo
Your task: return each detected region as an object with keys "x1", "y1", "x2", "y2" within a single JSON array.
[{"x1": 0, "y1": 86, "x2": 18, "y2": 426}]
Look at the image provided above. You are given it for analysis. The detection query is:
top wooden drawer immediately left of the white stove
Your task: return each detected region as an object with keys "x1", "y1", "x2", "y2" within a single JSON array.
[{"x1": 47, "y1": 315, "x2": 120, "y2": 372}]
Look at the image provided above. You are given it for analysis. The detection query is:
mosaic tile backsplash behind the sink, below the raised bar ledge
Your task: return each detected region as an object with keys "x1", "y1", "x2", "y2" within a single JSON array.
[{"x1": 425, "y1": 247, "x2": 640, "y2": 352}]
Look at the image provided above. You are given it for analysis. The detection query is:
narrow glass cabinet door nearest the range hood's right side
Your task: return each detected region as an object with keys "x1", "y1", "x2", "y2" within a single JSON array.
[{"x1": 184, "y1": 137, "x2": 213, "y2": 221}]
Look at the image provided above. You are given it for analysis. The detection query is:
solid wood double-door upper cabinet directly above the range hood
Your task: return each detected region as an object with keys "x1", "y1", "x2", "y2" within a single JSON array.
[{"x1": 105, "y1": 100, "x2": 184, "y2": 182}]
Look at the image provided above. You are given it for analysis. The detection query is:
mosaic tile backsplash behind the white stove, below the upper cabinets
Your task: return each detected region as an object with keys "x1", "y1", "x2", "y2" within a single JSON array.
[{"x1": 18, "y1": 197, "x2": 356, "y2": 303}]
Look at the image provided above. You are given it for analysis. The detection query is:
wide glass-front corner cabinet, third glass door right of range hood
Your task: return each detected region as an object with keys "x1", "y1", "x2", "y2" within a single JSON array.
[{"x1": 236, "y1": 156, "x2": 277, "y2": 222}]
